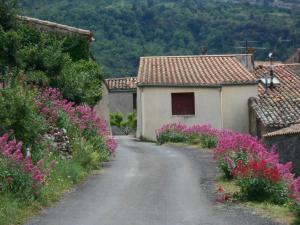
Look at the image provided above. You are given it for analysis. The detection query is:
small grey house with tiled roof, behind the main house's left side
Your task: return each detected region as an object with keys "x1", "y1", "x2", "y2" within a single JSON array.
[{"x1": 105, "y1": 77, "x2": 137, "y2": 115}]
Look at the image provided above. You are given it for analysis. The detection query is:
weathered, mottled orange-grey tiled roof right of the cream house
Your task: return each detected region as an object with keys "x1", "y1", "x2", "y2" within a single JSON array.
[{"x1": 250, "y1": 64, "x2": 300, "y2": 128}]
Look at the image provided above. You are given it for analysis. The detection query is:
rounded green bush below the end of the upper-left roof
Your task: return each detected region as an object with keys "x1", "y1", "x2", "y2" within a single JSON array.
[{"x1": 58, "y1": 60, "x2": 103, "y2": 106}]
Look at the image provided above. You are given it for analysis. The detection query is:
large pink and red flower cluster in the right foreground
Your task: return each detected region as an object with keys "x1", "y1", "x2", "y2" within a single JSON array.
[{"x1": 214, "y1": 132, "x2": 300, "y2": 204}]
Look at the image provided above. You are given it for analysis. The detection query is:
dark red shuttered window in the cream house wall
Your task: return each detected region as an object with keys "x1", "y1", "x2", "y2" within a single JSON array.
[{"x1": 171, "y1": 93, "x2": 195, "y2": 115}]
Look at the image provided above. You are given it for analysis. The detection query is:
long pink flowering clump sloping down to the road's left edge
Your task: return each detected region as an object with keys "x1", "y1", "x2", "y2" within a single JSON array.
[{"x1": 36, "y1": 88, "x2": 117, "y2": 158}]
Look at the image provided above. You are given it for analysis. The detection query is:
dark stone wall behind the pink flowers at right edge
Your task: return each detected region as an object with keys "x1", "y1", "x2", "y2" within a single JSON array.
[{"x1": 264, "y1": 134, "x2": 300, "y2": 175}]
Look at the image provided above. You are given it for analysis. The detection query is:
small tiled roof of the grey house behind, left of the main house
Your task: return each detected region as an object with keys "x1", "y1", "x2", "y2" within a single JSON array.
[{"x1": 105, "y1": 77, "x2": 136, "y2": 91}]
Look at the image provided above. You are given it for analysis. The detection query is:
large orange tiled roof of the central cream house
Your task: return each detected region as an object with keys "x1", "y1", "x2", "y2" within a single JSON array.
[{"x1": 138, "y1": 55, "x2": 256, "y2": 86}]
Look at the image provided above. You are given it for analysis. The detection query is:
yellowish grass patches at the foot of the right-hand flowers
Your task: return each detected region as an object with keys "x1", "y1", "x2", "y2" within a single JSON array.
[{"x1": 217, "y1": 177, "x2": 296, "y2": 225}]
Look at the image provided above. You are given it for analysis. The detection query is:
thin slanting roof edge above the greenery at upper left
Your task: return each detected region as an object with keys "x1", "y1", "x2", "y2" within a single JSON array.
[{"x1": 17, "y1": 16, "x2": 93, "y2": 41}]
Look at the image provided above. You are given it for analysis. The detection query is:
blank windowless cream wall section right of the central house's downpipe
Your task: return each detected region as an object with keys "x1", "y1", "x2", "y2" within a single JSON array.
[{"x1": 222, "y1": 85, "x2": 258, "y2": 133}]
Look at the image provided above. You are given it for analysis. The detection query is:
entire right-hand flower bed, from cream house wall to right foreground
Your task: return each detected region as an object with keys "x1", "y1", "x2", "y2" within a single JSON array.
[{"x1": 156, "y1": 123, "x2": 300, "y2": 209}]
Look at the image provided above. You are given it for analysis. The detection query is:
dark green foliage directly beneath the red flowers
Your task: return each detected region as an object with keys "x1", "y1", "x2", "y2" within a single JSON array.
[{"x1": 237, "y1": 178, "x2": 289, "y2": 205}]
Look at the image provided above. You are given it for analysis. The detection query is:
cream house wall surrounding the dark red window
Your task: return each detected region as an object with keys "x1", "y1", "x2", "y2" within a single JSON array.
[{"x1": 137, "y1": 87, "x2": 222, "y2": 140}]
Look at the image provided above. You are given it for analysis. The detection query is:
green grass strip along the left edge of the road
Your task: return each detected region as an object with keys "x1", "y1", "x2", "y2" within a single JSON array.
[{"x1": 0, "y1": 160, "x2": 97, "y2": 225}]
